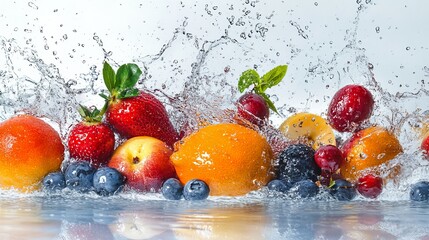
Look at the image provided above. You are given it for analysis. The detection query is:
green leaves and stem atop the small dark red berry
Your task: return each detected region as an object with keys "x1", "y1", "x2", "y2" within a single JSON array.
[{"x1": 238, "y1": 65, "x2": 287, "y2": 114}]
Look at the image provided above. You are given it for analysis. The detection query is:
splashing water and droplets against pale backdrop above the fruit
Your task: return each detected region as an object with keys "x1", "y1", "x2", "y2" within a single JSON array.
[{"x1": 0, "y1": 1, "x2": 429, "y2": 204}]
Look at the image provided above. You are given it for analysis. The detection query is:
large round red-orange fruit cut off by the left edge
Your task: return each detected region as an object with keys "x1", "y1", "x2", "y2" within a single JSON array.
[{"x1": 0, "y1": 115, "x2": 64, "y2": 191}]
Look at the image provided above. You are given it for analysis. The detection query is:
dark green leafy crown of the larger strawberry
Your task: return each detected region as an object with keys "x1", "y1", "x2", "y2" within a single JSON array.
[{"x1": 100, "y1": 61, "x2": 142, "y2": 102}]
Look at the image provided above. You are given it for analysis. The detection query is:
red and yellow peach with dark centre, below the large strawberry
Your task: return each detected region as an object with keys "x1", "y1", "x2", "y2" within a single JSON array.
[{"x1": 108, "y1": 136, "x2": 176, "y2": 191}]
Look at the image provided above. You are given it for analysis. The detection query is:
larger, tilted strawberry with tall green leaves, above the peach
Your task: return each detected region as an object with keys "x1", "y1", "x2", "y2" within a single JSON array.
[{"x1": 101, "y1": 62, "x2": 178, "y2": 147}]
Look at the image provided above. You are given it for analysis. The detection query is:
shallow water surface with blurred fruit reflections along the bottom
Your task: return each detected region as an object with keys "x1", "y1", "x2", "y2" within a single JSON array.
[{"x1": 0, "y1": 197, "x2": 429, "y2": 239}]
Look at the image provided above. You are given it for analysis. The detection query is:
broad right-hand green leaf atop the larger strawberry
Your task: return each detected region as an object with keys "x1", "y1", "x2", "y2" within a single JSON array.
[{"x1": 115, "y1": 63, "x2": 142, "y2": 90}]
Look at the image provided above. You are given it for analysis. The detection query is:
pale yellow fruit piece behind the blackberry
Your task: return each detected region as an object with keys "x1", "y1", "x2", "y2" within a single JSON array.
[{"x1": 279, "y1": 112, "x2": 336, "y2": 150}]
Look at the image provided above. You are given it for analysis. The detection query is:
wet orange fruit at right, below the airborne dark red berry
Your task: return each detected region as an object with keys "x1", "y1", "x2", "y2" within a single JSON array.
[{"x1": 340, "y1": 126, "x2": 402, "y2": 180}]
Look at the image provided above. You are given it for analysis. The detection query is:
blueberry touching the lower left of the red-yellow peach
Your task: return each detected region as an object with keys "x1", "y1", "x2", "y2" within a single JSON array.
[{"x1": 92, "y1": 167, "x2": 125, "y2": 196}]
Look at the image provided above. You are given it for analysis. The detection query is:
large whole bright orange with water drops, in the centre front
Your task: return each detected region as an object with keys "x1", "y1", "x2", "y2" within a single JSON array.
[{"x1": 170, "y1": 123, "x2": 274, "y2": 196}]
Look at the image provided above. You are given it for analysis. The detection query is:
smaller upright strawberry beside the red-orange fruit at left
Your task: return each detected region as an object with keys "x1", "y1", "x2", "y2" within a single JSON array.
[{"x1": 68, "y1": 106, "x2": 115, "y2": 167}]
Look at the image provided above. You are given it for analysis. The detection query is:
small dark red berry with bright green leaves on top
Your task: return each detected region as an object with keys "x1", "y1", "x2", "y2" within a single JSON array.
[{"x1": 237, "y1": 65, "x2": 287, "y2": 126}]
